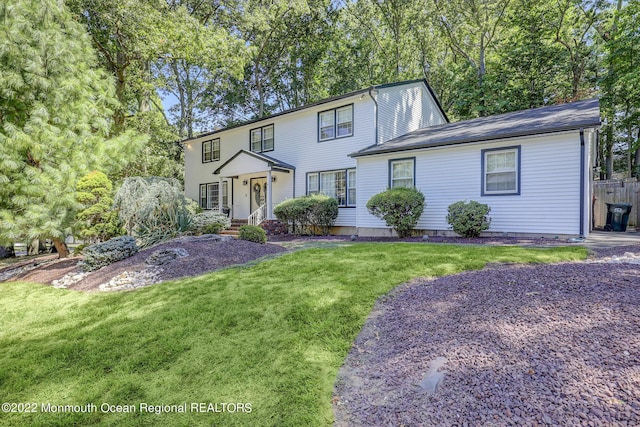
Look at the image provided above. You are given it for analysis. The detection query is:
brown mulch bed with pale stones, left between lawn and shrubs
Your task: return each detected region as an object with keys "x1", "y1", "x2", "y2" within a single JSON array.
[{"x1": 0, "y1": 237, "x2": 287, "y2": 291}]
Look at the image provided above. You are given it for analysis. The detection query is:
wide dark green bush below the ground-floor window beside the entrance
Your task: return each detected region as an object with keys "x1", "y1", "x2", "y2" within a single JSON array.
[{"x1": 273, "y1": 194, "x2": 338, "y2": 235}]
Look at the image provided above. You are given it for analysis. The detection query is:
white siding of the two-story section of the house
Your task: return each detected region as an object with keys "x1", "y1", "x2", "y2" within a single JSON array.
[{"x1": 184, "y1": 83, "x2": 444, "y2": 227}]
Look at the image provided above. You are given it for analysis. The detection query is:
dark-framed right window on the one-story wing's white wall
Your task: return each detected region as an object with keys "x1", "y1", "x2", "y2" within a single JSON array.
[{"x1": 482, "y1": 146, "x2": 520, "y2": 196}]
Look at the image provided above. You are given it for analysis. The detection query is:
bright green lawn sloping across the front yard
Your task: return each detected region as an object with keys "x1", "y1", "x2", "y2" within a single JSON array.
[{"x1": 0, "y1": 243, "x2": 586, "y2": 426}]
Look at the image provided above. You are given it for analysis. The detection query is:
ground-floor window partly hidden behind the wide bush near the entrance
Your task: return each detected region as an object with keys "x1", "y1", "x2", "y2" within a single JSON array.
[{"x1": 307, "y1": 169, "x2": 356, "y2": 207}]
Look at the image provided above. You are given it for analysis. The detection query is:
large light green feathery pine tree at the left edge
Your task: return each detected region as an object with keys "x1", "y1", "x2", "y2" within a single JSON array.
[{"x1": 0, "y1": 0, "x2": 142, "y2": 251}]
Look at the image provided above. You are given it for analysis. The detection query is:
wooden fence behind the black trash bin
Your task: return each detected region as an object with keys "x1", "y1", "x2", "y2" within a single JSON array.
[{"x1": 593, "y1": 180, "x2": 640, "y2": 228}]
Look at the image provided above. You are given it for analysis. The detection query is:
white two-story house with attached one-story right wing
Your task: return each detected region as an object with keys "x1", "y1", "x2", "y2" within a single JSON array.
[{"x1": 183, "y1": 80, "x2": 600, "y2": 236}]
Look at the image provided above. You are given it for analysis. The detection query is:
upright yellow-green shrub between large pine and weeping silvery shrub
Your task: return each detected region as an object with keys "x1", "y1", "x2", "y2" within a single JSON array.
[{"x1": 75, "y1": 171, "x2": 124, "y2": 243}]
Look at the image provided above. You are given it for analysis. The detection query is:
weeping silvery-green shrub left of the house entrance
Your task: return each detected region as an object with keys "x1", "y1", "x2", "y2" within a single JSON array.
[{"x1": 114, "y1": 177, "x2": 197, "y2": 247}]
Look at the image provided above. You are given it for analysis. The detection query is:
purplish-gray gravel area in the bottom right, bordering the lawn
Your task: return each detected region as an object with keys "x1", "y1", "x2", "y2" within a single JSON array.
[{"x1": 334, "y1": 252, "x2": 640, "y2": 426}]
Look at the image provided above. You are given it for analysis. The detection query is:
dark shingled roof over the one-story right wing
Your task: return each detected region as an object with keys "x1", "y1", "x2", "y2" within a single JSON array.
[{"x1": 350, "y1": 98, "x2": 600, "y2": 157}]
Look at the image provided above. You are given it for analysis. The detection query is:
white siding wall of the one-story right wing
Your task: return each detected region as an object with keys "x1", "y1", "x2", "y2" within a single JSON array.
[{"x1": 356, "y1": 131, "x2": 589, "y2": 236}]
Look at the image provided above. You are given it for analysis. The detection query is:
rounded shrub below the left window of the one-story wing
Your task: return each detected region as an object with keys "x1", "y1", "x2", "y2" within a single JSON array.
[{"x1": 367, "y1": 188, "x2": 424, "y2": 237}]
